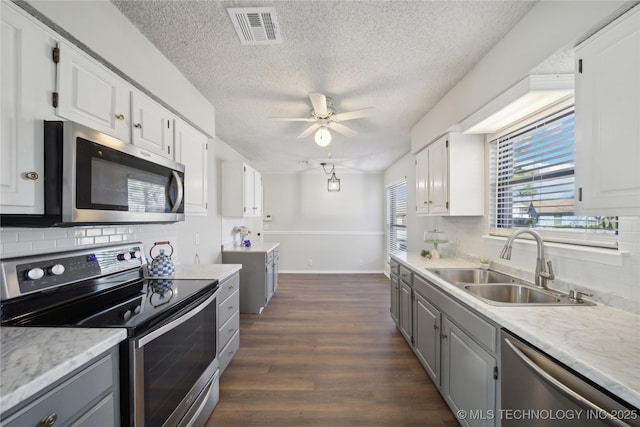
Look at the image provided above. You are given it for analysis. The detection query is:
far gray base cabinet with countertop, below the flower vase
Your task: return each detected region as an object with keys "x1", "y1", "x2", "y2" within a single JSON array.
[{"x1": 222, "y1": 248, "x2": 278, "y2": 313}]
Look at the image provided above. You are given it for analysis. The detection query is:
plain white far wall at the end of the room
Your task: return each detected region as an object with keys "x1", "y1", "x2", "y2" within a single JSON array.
[{"x1": 262, "y1": 170, "x2": 385, "y2": 273}]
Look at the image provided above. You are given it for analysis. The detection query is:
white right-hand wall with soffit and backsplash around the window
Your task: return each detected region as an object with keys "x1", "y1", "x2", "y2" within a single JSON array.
[{"x1": 402, "y1": 2, "x2": 640, "y2": 312}]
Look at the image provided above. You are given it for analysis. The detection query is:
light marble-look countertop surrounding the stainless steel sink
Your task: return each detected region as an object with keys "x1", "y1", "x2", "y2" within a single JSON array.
[{"x1": 394, "y1": 254, "x2": 640, "y2": 408}]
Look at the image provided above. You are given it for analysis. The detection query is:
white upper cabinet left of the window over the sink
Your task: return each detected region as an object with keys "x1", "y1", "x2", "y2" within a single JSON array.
[{"x1": 416, "y1": 133, "x2": 484, "y2": 216}]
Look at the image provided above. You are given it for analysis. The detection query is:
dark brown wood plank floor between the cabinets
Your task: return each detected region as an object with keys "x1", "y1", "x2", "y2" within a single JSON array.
[{"x1": 207, "y1": 274, "x2": 458, "y2": 427}]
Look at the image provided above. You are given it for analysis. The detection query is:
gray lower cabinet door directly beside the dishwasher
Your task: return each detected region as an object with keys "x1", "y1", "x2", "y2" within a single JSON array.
[{"x1": 441, "y1": 316, "x2": 497, "y2": 426}]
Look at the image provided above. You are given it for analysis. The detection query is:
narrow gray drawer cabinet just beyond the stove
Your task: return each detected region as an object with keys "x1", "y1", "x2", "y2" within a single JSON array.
[{"x1": 216, "y1": 273, "x2": 240, "y2": 375}]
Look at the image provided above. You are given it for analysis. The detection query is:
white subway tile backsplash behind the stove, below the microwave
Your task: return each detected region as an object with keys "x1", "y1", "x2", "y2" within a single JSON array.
[{"x1": 0, "y1": 224, "x2": 179, "y2": 262}]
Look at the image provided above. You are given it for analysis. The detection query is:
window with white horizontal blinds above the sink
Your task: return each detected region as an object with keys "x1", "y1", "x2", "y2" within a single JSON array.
[{"x1": 490, "y1": 106, "x2": 618, "y2": 247}]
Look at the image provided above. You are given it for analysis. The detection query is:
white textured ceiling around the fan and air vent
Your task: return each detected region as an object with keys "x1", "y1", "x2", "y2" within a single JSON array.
[{"x1": 113, "y1": 0, "x2": 533, "y2": 172}]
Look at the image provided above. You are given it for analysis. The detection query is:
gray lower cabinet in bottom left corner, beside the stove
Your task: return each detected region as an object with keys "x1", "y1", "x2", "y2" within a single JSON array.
[{"x1": 0, "y1": 347, "x2": 120, "y2": 427}]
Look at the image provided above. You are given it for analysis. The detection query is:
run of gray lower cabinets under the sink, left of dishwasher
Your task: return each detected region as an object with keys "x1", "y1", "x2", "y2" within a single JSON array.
[{"x1": 391, "y1": 258, "x2": 499, "y2": 426}]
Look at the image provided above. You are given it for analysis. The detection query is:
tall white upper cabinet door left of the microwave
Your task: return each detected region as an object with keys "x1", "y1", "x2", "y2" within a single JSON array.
[{"x1": 0, "y1": 2, "x2": 57, "y2": 214}]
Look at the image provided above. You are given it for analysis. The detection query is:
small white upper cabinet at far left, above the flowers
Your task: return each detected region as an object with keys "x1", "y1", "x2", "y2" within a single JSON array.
[{"x1": 222, "y1": 162, "x2": 262, "y2": 217}]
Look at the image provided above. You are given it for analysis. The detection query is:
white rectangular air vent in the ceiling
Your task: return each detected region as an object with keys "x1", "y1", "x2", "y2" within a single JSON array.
[{"x1": 227, "y1": 7, "x2": 282, "y2": 45}]
